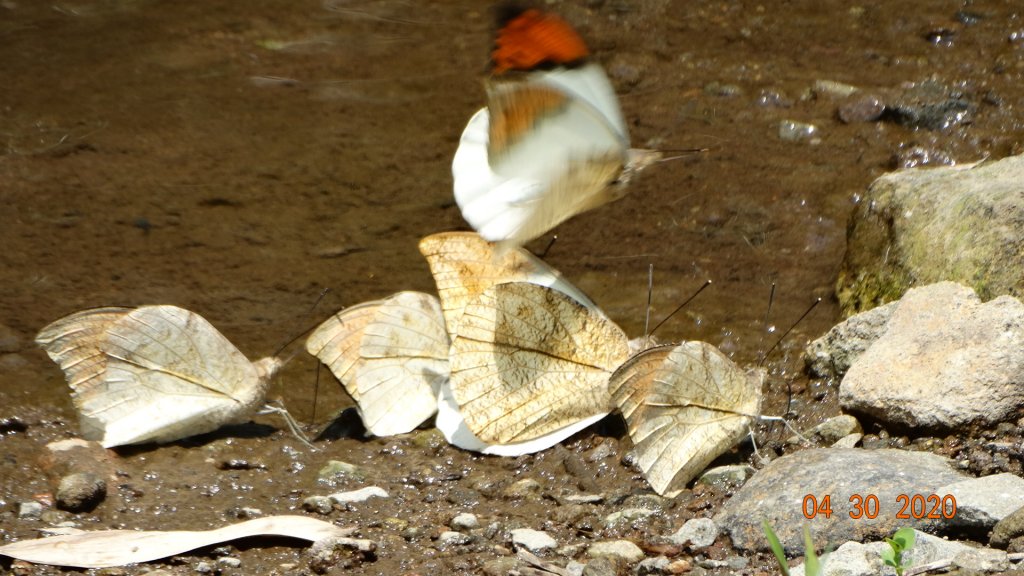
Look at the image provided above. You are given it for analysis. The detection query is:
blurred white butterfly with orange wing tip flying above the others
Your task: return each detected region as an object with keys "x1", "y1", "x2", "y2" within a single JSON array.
[{"x1": 452, "y1": 9, "x2": 660, "y2": 246}]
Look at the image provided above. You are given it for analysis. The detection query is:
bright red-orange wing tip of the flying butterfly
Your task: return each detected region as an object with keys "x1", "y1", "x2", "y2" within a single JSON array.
[{"x1": 490, "y1": 9, "x2": 590, "y2": 74}]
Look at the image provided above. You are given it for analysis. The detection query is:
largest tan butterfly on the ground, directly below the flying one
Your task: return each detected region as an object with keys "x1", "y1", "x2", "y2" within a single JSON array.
[{"x1": 420, "y1": 233, "x2": 629, "y2": 455}]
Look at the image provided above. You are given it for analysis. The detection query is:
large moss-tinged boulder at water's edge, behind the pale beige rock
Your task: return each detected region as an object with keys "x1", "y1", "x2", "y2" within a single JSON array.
[{"x1": 836, "y1": 156, "x2": 1024, "y2": 315}]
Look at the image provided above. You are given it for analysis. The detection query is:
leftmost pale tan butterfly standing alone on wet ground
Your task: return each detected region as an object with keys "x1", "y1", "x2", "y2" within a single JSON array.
[{"x1": 36, "y1": 305, "x2": 280, "y2": 447}]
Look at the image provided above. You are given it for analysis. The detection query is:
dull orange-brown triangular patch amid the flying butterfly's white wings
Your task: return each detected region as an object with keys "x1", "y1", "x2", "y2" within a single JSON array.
[{"x1": 487, "y1": 83, "x2": 567, "y2": 159}]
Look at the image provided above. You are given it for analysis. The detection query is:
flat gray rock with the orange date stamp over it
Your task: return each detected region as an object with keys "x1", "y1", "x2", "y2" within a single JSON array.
[{"x1": 714, "y1": 448, "x2": 966, "y2": 554}]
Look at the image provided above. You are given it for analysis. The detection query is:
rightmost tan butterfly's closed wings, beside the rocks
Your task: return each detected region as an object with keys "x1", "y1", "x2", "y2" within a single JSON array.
[{"x1": 609, "y1": 341, "x2": 762, "y2": 497}]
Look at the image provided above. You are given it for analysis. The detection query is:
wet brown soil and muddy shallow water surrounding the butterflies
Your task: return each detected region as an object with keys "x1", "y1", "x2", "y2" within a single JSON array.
[{"x1": 0, "y1": 0, "x2": 1024, "y2": 574}]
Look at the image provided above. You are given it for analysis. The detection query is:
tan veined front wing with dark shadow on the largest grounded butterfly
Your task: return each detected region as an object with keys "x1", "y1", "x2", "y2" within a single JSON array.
[{"x1": 450, "y1": 283, "x2": 629, "y2": 444}]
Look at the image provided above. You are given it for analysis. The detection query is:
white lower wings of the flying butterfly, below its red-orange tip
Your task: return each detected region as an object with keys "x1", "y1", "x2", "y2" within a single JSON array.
[{"x1": 452, "y1": 65, "x2": 629, "y2": 246}]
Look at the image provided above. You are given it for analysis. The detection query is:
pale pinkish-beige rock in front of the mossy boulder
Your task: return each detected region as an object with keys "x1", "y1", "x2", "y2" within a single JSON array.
[{"x1": 840, "y1": 282, "x2": 1024, "y2": 429}]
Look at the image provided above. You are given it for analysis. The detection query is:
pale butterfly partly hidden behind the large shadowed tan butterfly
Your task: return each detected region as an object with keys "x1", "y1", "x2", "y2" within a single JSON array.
[{"x1": 306, "y1": 292, "x2": 451, "y2": 437}]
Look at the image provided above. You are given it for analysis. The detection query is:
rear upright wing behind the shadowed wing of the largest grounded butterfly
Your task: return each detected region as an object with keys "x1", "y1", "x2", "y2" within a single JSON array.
[{"x1": 420, "y1": 232, "x2": 598, "y2": 335}]
